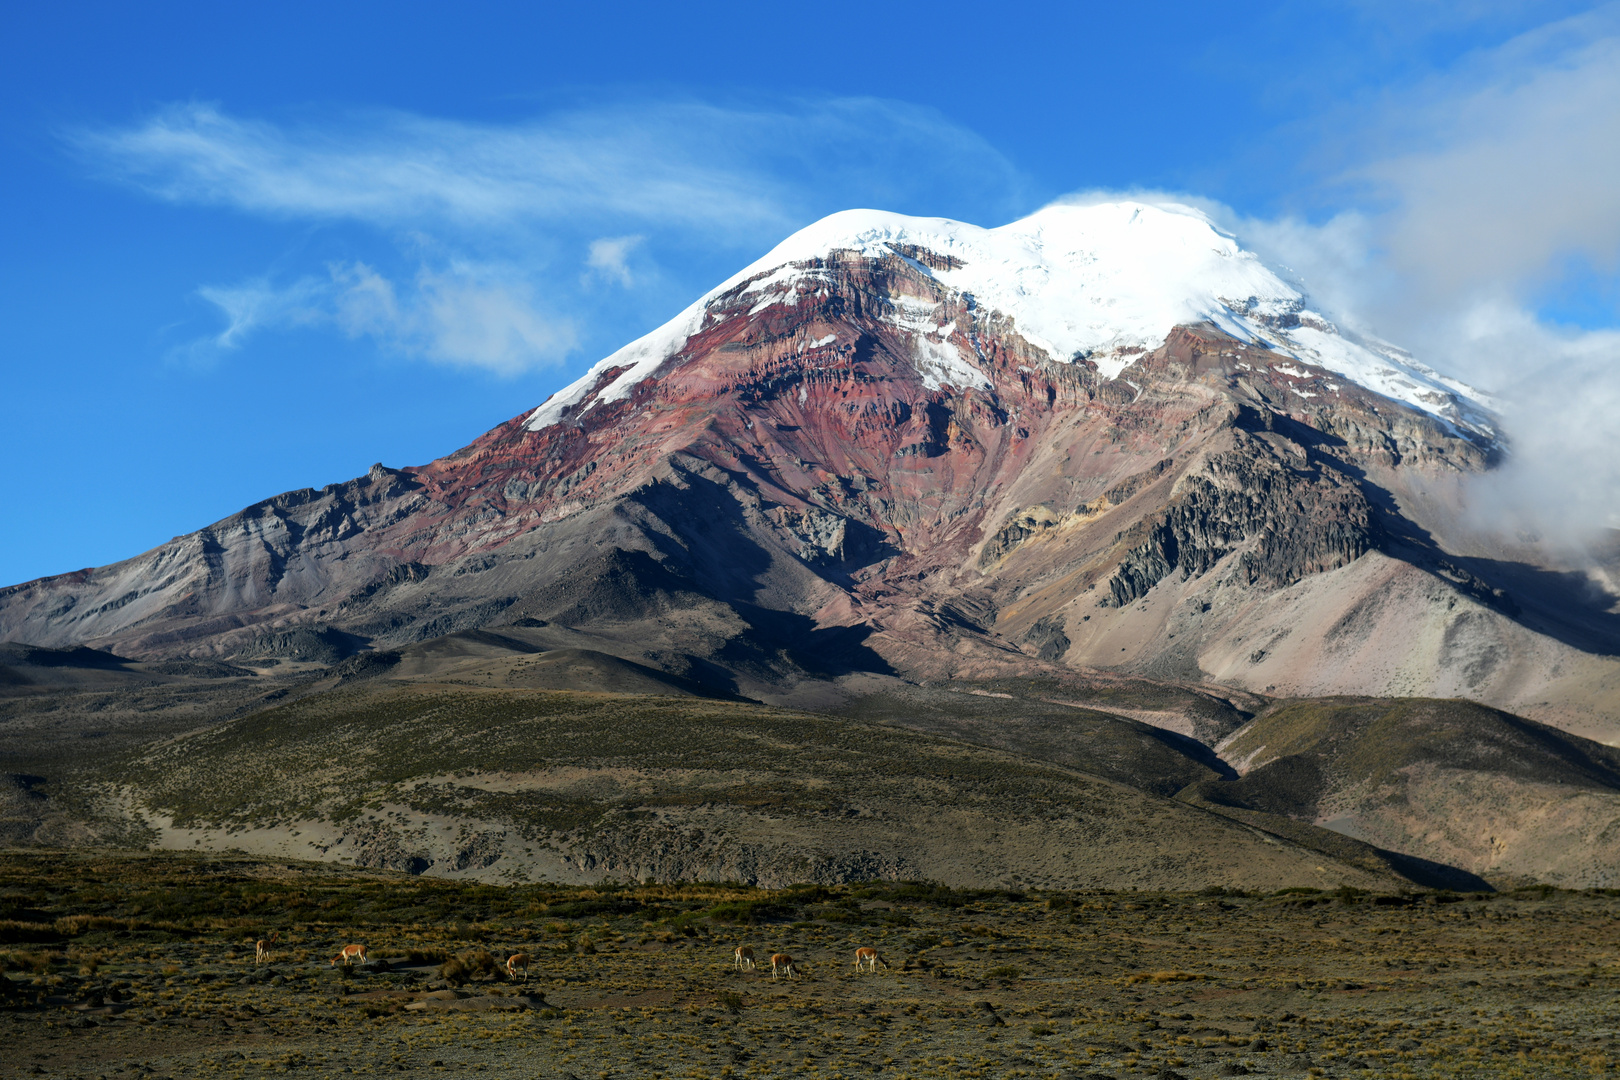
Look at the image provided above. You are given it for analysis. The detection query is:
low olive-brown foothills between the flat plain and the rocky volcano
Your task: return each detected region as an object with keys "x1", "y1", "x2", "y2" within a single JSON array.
[{"x1": 0, "y1": 620, "x2": 1600, "y2": 889}]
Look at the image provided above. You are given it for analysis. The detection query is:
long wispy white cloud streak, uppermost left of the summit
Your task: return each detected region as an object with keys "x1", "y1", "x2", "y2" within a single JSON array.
[{"x1": 70, "y1": 99, "x2": 1021, "y2": 235}]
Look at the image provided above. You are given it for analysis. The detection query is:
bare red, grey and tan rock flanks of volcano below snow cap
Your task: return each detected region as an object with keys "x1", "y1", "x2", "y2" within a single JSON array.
[{"x1": 0, "y1": 210, "x2": 1620, "y2": 730}]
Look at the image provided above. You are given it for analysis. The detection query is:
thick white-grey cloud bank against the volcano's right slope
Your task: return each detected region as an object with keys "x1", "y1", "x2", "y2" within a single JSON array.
[{"x1": 1146, "y1": 5, "x2": 1620, "y2": 549}]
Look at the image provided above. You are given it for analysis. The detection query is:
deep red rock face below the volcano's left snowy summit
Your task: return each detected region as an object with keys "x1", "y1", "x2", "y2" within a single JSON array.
[{"x1": 430, "y1": 259, "x2": 1095, "y2": 551}]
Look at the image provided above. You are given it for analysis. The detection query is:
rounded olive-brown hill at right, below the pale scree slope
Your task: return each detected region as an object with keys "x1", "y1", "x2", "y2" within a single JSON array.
[{"x1": 1181, "y1": 698, "x2": 1620, "y2": 887}]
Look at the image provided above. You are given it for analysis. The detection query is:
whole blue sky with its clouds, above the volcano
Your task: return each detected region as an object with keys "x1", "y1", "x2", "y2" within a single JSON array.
[{"x1": 0, "y1": 0, "x2": 1620, "y2": 583}]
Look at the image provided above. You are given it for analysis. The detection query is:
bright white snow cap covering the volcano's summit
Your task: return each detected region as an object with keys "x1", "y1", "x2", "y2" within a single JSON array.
[{"x1": 527, "y1": 201, "x2": 1492, "y2": 434}]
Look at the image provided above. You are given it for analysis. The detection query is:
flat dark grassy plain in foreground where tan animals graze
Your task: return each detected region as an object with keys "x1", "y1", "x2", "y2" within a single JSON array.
[{"x1": 0, "y1": 852, "x2": 1620, "y2": 1080}]
